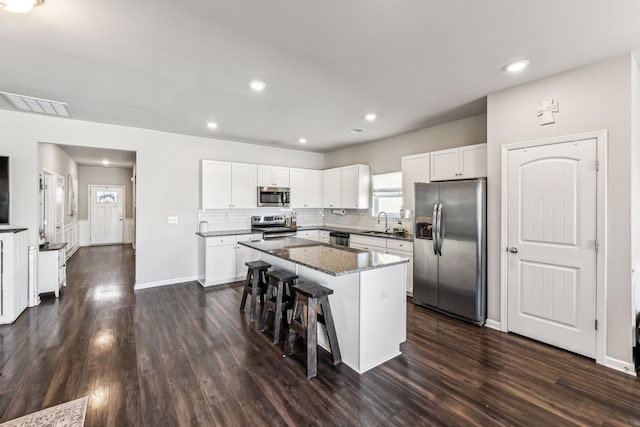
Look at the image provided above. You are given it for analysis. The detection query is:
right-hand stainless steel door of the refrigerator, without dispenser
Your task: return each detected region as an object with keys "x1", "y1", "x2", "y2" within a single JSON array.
[{"x1": 438, "y1": 180, "x2": 485, "y2": 320}]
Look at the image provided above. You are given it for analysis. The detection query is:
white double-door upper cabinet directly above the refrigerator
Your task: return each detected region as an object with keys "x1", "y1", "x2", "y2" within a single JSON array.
[{"x1": 430, "y1": 144, "x2": 487, "y2": 181}]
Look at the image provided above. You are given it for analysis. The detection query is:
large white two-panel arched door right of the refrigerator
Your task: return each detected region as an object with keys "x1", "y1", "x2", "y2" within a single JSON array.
[{"x1": 507, "y1": 139, "x2": 597, "y2": 357}]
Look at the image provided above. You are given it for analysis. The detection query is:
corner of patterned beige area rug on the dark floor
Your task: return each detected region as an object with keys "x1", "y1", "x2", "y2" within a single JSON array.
[{"x1": 0, "y1": 396, "x2": 88, "y2": 427}]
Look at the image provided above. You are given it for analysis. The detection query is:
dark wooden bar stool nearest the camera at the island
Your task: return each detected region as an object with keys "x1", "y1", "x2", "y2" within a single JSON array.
[{"x1": 284, "y1": 282, "x2": 342, "y2": 378}]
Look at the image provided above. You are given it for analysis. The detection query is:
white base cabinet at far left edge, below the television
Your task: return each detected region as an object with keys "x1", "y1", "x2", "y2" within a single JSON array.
[{"x1": 0, "y1": 229, "x2": 29, "y2": 324}]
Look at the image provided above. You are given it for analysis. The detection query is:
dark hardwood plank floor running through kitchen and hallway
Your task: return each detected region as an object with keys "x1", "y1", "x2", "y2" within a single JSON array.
[{"x1": 0, "y1": 246, "x2": 640, "y2": 427}]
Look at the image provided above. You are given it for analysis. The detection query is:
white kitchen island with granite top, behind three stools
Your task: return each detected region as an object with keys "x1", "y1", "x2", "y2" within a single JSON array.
[{"x1": 239, "y1": 237, "x2": 408, "y2": 374}]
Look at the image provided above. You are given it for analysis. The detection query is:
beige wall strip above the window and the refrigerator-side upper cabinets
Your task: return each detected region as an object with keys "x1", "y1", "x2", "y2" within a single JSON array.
[{"x1": 324, "y1": 114, "x2": 487, "y2": 174}]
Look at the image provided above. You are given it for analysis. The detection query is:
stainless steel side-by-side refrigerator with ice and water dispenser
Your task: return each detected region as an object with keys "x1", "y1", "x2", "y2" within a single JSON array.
[{"x1": 413, "y1": 178, "x2": 487, "y2": 325}]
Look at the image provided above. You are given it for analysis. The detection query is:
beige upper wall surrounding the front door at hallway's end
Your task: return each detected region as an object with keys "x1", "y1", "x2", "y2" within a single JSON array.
[{"x1": 78, "y1": 166, "x2": 133, "y2": 219}]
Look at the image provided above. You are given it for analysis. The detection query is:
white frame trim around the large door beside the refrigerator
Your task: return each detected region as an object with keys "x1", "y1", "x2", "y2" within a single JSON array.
[{"x1": 500, "y1": 130, "x2": 608, "y2": 365}]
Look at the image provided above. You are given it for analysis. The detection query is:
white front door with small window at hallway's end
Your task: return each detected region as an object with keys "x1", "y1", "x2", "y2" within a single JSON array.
[{"x1": 89, "y1": 186, "x2": 124, "y2": 245}]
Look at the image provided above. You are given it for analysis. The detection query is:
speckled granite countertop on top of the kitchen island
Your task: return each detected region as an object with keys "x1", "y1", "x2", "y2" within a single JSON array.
[{"x1": 239, "y1": 237, "x2": 409, "y2": 276}]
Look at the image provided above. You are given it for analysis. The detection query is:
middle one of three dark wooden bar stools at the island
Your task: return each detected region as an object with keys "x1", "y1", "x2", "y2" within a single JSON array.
[{"x1": 260, "y1": 270, "x2": 298, "y2": 344}]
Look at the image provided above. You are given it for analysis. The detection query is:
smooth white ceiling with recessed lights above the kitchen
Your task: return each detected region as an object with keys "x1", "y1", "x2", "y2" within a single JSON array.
[{"x1": 0, "y1": 0, "x2": 640, "y2": 152}]
